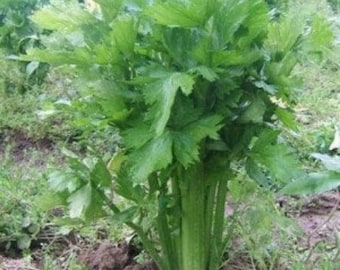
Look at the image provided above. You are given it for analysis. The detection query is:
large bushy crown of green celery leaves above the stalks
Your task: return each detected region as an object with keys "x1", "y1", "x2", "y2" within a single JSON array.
[{"x1": 22, "y1": 1, "x2": 331, "y2": 188}]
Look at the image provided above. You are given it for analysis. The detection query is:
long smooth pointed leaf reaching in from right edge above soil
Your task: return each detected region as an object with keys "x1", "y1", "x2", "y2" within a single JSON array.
[{"x1": 279, "y1": 172, "x2": 340, "y2": 195}]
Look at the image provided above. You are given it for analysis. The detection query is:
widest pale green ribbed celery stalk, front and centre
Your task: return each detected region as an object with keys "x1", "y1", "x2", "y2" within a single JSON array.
[{"x1": 179, "y1": 165, "x2": 207, "y2": 270}]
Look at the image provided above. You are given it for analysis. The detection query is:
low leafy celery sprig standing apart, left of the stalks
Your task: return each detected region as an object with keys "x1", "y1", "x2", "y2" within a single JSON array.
[{"x1": 41, "y1": 150, "x2": 112, "y2": 220}]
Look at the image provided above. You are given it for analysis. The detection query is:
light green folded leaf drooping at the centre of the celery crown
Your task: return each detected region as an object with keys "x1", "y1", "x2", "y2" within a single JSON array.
[{"x1": 144, "y1": 72, "x2": 194, "y2": 136}]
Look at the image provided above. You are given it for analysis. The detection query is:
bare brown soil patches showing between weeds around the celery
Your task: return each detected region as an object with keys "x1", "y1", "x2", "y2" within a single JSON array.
[{"x1": 0, "y1": 134, "x2": 340, "y2": 270}]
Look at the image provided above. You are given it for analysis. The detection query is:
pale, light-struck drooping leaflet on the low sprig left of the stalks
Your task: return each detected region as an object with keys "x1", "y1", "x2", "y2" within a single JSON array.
[{"x1": 67, "y1": 184, "x2": 92, "y2": 218}]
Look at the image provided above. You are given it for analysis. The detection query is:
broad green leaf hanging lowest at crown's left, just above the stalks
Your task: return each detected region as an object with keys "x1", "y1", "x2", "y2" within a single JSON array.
[{"x1": 129, "y1": 131, "x2": 173, "y2": 183}]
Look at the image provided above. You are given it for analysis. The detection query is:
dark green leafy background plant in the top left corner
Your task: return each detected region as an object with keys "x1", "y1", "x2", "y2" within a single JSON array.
[{"x1": 0, "y1": 0, "x2": 48, "y2": 93}]
